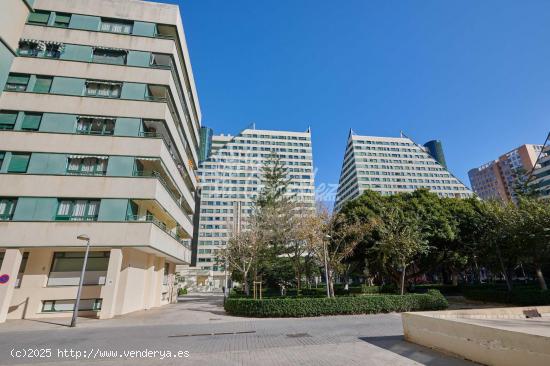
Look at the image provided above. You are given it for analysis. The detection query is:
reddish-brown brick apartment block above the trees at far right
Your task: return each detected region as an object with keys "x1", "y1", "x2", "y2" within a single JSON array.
[{"x1": 468, "y1": 145, "x2": 542, "y2": 202}]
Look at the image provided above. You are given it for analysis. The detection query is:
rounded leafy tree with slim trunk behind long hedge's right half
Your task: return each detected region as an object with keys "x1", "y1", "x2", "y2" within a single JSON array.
[{"x1": 373, "y1": 206, "x2": 430, "y2": 295}]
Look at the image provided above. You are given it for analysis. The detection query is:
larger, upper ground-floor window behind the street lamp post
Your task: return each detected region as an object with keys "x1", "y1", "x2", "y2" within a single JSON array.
[{"x1": 48, "y1": 252, "x2": 109, "y2": 286}]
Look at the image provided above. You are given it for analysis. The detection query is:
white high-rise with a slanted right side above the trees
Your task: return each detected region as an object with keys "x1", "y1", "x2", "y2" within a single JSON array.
[{"x1": 334, "y1": 131, "x2": 472, "y2": 211}]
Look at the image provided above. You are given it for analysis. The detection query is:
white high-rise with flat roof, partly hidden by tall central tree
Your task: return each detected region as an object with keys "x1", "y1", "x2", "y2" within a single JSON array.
[{"x1": 182, "y1": 129, "x2": 315, "y2": 291}]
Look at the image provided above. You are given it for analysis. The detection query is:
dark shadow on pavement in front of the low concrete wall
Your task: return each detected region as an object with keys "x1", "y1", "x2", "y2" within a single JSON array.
[{"x1": 359, "y1": 336, "x2": 478, "y2": 366}]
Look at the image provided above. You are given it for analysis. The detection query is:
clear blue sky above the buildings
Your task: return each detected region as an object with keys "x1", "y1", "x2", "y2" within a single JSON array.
[{"x1": 157, "y1": 0, "x2": 550, "y2": 199}]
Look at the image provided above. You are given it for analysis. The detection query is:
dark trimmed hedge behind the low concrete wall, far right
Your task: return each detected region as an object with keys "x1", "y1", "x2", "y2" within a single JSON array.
[{"x1": 462, "y1": 287, "x2": 550, "y2": 306}]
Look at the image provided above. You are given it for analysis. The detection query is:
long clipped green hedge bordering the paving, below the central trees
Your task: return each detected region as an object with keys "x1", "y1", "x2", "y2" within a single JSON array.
[{"x1": 224, "y1": 290, "x2": 448, "y2": 317}]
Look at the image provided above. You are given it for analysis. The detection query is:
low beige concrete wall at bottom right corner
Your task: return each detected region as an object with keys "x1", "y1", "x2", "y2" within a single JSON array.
[{"x1": 402, "y1": 306, "x2": 550, "y2": 366}]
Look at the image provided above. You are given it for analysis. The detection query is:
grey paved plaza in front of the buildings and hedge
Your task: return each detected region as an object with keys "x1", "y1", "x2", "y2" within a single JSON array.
[{"x1": 0, "y1": 296, "x2": 478, "y2": 366}]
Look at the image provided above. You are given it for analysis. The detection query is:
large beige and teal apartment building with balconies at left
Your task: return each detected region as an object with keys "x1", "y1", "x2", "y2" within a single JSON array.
[{"x1": 0, "y1": 0, "x2": 201, "y2": 322}]
